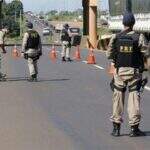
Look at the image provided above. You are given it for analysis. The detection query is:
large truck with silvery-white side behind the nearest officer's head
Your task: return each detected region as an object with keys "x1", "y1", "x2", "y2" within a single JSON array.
[{"x1": 108, "y1": 0, "x2": 150, "y2": 41}]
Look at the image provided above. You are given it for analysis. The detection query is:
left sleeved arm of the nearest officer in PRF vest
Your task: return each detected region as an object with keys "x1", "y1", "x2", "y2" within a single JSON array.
[{"x1": 106, "y1": 34, "x2": 116, "y2": 61}]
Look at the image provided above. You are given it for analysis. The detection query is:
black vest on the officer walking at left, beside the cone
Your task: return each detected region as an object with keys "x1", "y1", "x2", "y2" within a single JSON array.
[{"x1": 26, "y1": 30, "x2": 40, "y2": 49}]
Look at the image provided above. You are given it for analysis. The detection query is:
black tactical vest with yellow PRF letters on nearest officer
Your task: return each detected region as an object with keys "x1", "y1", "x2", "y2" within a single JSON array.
[{"x1": 115, "y1": 33, "x2": 144, "y2": 69}]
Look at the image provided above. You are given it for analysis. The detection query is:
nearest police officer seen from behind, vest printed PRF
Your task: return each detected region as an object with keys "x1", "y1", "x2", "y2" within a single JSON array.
[{"x1": 107, "y1": 12, "x2": 146, "y2": 137}]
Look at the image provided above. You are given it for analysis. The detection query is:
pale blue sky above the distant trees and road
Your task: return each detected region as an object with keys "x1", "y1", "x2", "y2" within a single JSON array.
[{"x1": 6, "y1": 0, "x2": 108, "y2": 12}]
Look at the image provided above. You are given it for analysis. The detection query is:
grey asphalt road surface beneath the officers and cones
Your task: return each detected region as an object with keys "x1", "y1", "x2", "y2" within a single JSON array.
[{"x1": 0, "y1": 47, "x2": 150, "y2": 150}]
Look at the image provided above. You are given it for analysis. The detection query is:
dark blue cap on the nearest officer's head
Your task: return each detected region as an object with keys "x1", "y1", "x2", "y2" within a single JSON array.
[{"x1": 122, "y1": 12, "x2": 135, "y2": 27}]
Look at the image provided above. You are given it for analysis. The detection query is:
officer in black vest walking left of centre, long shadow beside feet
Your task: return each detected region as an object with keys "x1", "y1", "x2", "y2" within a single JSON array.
[{"x1": 22, "y1": 22, "x2": 42, "y2": 81}]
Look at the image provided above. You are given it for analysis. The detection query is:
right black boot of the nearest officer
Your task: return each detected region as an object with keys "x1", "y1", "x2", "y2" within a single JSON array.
[{"x1": 129, "y1": 124, "x2": 145, "y2": 137}]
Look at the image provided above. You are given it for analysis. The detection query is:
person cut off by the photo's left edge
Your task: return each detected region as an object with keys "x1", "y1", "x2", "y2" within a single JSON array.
[{"x1": 0, "y1": 29, "x2": 8, "y2": 81}]
